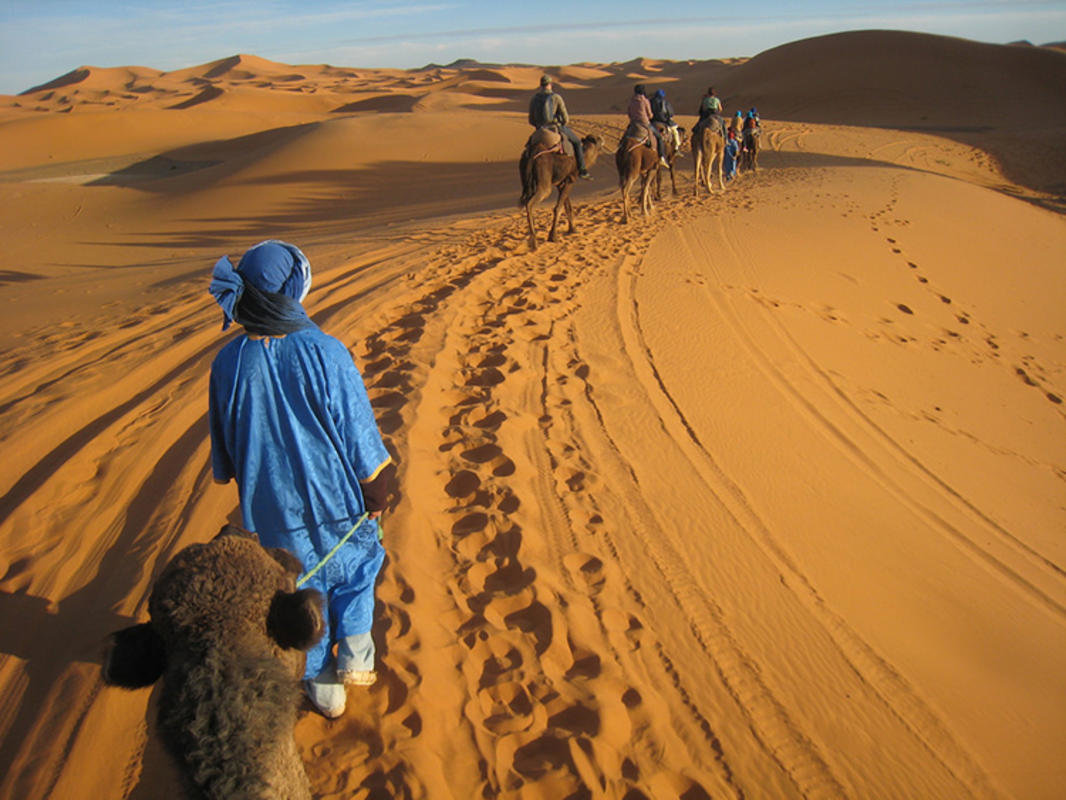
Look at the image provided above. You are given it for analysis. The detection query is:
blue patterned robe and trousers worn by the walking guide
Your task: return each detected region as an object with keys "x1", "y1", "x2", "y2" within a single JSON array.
[{"x1": 209, "y1": 326, "x2": 389, "y2": 677}]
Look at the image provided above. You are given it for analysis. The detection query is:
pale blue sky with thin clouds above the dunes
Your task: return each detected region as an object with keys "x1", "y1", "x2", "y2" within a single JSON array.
[{"x1": 0, "y1": 0, "x2": 1066, "y2": 94}]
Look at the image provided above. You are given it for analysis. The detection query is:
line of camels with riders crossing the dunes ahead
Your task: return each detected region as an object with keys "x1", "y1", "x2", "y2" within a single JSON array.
[{"x1": 518, "y1": 75, "x2": 762, "y2": 243}]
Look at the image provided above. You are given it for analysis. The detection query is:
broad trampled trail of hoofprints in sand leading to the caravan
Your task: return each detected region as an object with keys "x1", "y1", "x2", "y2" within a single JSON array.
[{"x1": 289, "y1": 183, "x2": 767, "y2": 798}]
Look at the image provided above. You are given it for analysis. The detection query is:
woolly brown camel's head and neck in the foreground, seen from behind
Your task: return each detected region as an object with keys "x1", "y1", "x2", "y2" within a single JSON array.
[{"x1": 103, "y1": 525, "x2": 325, "y2": 800}]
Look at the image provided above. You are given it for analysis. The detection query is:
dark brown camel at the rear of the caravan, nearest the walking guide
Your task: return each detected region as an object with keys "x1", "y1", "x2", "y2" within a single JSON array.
[{"x1": 518, "y1": 128, "x2": 603, "y2": 250}]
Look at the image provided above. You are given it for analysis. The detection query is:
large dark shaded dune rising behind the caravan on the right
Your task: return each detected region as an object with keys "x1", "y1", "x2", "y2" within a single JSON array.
[{"x1": 737, "y1": 31, "x2": 1066, "y2": 127}]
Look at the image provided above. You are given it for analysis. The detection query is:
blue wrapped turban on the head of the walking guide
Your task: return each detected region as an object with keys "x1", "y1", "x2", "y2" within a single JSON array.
[{"x1": 208, "y1": 239, "x2": 312, "y2": 336}]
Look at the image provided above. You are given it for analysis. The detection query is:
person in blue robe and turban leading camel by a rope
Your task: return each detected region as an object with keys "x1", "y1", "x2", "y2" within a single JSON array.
[{"x1": 209, "y1": 240, "x2": 394, "y2": 718}]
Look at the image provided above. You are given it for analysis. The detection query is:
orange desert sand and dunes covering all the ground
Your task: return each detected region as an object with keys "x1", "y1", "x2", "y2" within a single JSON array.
[{"x1": 0, "y1": 32, "x2": 1066, "y2": 800}]
